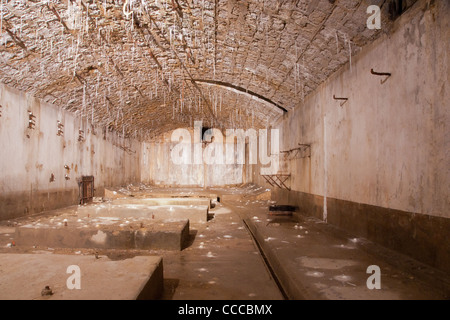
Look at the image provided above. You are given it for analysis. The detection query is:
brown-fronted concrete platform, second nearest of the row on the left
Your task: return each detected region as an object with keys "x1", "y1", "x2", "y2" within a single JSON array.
[{"x1": 14, "y1": 219, "x2": 189, "y2": 250}]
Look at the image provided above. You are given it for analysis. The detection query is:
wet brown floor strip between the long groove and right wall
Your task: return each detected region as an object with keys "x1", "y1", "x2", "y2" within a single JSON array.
[{"x1": 228, "y1": 202, "x2": 450, "y2": 300}]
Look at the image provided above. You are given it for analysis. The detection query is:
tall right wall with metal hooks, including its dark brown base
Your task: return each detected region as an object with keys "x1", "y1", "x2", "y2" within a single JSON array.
[{"x1": 254, "y1": 1, "x2": 450, "y2": 270}]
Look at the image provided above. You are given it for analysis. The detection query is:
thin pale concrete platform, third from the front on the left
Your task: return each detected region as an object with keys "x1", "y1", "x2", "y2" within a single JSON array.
[{"x1": 76, "y1": 199, "x2": 208, "y2": 223}]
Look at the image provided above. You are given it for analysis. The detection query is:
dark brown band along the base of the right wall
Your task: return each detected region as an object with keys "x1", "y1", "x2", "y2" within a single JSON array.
[{"x1": 272, "y1": 190, "x2": 450, "y2": 271}]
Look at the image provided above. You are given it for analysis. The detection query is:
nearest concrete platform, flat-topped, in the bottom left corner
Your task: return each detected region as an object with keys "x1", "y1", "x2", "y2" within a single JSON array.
[{"x1": 0, "y1": 254, "x2": 163, "y2": 300}]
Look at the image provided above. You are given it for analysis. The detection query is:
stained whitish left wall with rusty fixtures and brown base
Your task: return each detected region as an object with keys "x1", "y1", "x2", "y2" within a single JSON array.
[{"x1": 0, "y1": 85, "x2": 140, "y2": 219}]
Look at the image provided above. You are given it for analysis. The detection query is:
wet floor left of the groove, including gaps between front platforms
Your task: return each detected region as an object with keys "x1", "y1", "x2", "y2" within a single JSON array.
[{"x1": 0, "y1": 195, "x2": 283, "y2": 300}]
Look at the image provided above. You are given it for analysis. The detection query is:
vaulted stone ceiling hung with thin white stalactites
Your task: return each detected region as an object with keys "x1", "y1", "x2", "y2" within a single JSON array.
[{"x1": 0, "y1": 0, "x2": 408, "y2": 139}]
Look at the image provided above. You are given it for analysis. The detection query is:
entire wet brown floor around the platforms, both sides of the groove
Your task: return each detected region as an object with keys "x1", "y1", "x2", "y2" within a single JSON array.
[{"x1": 0, "y1": 188, "x2": 450, "y2": 300}]
